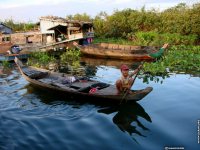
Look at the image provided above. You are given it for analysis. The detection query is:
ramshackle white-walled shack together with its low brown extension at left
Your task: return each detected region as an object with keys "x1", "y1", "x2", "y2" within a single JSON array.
[{"x1": 0, "y1": 16, "x2": 94, "y2": 50}]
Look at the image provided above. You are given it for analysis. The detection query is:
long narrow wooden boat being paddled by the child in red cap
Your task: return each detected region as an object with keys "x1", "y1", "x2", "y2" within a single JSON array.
[{"x1": 15, "y1": 57, "x2": 153, "y2": 103}]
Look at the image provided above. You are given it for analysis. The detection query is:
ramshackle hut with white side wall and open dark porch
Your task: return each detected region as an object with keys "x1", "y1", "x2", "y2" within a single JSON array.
[{"x1": 40, "y1": 16, "x2": 94, "y2": 43}]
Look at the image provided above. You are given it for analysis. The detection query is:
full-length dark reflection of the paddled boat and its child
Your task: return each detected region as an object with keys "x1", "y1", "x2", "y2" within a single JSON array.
[{"x1": 25, "y1": 84, "x2": 152, "y2": 143}]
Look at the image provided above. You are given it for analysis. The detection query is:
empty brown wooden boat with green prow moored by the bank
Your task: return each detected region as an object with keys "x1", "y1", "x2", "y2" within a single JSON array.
[{"x1": 73, "y1": 42, "x2": 163, "y2": 61}]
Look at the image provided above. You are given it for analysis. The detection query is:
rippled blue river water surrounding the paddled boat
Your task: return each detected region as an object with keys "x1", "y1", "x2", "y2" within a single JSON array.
[{"x1": 0, "y1": 60, "x2": 200, "y2": 150}]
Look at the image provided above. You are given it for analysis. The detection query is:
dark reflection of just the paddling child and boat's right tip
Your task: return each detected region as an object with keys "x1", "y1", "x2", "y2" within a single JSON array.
[{"x1": 98, "y1": 102, "x2": 152, "y2": 143}]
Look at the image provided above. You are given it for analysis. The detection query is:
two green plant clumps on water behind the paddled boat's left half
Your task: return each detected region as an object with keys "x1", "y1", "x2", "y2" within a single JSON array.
[{"x1": 27, "y1": 49, "x2": 81, "y2": 74}]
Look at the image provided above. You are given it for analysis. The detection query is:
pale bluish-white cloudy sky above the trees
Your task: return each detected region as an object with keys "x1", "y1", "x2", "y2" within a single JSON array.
[{"x1": 0, "y1": 0, "x2": 200, "y2": 23}]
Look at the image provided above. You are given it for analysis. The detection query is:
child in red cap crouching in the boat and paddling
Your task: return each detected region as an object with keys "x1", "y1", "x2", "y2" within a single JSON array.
[{"x1": 116, "y1": 65, "x2": 142, "y2": 94}]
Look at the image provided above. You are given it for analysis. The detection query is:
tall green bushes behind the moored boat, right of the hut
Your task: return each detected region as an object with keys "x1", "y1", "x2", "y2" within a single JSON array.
[{"x1": 93, "y1": 3, "x2": 200, "y2": 44}]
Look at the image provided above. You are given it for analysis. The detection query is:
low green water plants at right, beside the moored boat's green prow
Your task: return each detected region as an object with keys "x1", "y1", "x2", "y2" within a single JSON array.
[{"x1": 144, "y1": 45, "x2": 200, "y2": 75}]
